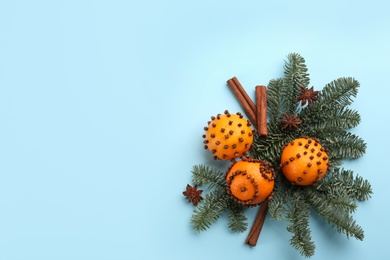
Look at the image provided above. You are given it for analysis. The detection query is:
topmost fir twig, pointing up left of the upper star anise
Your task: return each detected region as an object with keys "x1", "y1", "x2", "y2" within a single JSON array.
[{"x1": 280, "y1": 53, "x2": 310, "y2": 114}]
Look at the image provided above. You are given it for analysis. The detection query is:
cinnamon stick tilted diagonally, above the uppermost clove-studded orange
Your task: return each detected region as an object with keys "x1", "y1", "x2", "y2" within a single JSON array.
[{"x1": 227, "y1": 77, "x2": 257, "y2": 126}]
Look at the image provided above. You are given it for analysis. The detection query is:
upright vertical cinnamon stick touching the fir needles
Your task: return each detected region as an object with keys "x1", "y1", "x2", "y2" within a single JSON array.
[{"x1": 256, "y1": 86, "x2": 268, "y2": 137}]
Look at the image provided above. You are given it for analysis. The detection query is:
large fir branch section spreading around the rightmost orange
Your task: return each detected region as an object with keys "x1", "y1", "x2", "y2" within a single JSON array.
[{"x1": 258, "y1": 54, "x2": 372, "y2": 257}]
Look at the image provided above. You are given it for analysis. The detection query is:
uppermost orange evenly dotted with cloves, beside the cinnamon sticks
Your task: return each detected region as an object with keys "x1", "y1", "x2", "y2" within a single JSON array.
[{"x1": 203, "y1": 110, "x2": 254, "y2": 160}]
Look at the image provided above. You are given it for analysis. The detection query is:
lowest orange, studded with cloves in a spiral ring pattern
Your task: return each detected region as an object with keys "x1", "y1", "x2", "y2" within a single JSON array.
[{"x1": 225, "y1": 156, "x2": 275, "y2": 207}]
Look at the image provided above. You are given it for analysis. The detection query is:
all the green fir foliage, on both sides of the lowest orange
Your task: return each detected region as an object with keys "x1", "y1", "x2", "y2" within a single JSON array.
[{"x1": 183, "y1": 53, "x2": 373, "y2": 257}]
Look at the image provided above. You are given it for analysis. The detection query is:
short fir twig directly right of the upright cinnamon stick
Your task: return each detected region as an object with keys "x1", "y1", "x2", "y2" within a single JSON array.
[{"x1": 267, "y1": 78, "x2": 286, "y2": 122}]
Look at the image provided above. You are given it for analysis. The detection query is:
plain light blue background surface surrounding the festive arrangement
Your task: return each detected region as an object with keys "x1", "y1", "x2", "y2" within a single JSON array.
[{"x1": 0, "y1": 0, "x2": 390, "y2": 260}]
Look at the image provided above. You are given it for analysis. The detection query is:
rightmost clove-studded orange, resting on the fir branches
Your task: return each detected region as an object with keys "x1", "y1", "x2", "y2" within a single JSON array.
[{"x1": 280, "y1": 137, "x2": 331, "y2": 186}]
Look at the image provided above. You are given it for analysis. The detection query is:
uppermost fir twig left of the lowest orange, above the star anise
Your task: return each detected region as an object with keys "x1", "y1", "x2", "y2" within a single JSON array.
[{"x1": 192, "y1": 164, "x2": 225, "y2": 189}]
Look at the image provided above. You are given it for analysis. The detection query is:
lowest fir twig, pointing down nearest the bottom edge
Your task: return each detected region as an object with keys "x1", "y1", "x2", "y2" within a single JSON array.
[{"x1": 287, "y1": 192, "x2": 315, "y2": 257}]
